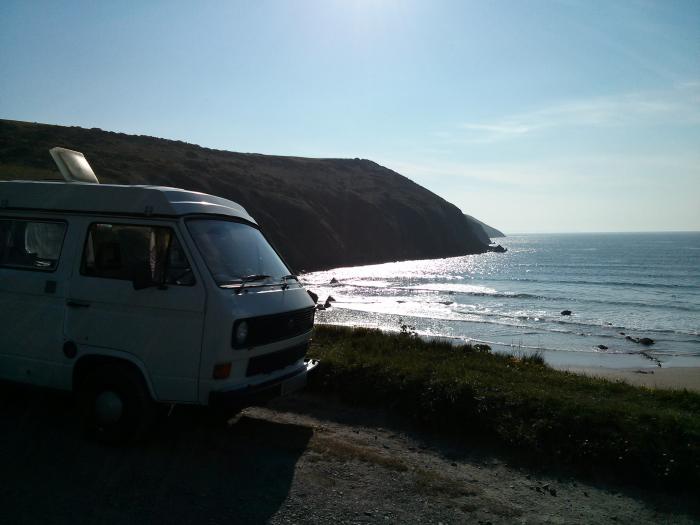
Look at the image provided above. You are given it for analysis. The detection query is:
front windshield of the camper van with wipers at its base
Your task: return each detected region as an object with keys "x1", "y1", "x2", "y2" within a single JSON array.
[{"x1": 187, "y1": 219, "x2": 290, "y2": 286}]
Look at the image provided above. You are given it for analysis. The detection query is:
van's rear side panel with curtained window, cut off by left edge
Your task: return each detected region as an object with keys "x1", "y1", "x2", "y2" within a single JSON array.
[{"x1": 0, "y1": 217, "x2": 70, "y2": 388}]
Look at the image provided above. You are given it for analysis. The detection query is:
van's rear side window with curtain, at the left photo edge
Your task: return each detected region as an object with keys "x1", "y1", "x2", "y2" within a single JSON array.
[{"x1": 0, "y1": 219, "x2": 66, "y2": 271}]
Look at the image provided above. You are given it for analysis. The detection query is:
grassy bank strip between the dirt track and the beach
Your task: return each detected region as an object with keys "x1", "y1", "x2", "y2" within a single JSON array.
[{"x1": 310, "y1": 326, "x2": 700, "y2": 487}]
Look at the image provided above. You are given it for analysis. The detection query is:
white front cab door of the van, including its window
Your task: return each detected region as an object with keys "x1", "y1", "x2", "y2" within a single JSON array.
[{"x1": 65, "y1": 219, "x2": 206, "y2": 402}]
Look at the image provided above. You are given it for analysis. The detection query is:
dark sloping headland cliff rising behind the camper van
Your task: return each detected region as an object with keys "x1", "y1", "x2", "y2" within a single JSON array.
[{"x1": 0, "y1": 120, "x2": 486, "y2": 271}]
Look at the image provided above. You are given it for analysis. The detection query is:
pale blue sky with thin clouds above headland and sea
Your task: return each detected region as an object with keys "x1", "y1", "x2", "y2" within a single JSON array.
[{"x1": 0, "y1": 0, "x2": 700, "y2": 233}]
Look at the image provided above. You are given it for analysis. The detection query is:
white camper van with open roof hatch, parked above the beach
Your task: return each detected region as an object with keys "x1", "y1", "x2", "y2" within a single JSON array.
[{"x1": 0, "y1": 148, "x2": 317, "y2": 442}]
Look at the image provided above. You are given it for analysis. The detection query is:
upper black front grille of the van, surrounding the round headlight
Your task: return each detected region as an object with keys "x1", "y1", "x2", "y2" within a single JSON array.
[{"x1": 231, "y1": 306, "x2": 315, "y2": 348}]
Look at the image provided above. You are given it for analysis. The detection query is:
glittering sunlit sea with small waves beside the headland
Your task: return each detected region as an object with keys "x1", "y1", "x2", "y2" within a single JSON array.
[{"x1": 302, "y1": 232, "x2": 700, "y2": 368}]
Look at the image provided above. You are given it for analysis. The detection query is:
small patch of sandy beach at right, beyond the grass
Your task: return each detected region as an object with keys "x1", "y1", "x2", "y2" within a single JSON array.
[{"x1": 560, "y1": 366, "x2": 700, "y2": 392}]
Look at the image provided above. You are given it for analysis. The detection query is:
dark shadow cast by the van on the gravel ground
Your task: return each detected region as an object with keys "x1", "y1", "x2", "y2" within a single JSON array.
[{"x1": 0, "y1": 384, "x2": 312, "y2": 525}]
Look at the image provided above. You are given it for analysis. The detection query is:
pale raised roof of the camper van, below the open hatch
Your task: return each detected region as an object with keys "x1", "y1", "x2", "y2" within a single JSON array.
[{"x1": 0, "y1": 181, "x2": 257, "y2": 224}]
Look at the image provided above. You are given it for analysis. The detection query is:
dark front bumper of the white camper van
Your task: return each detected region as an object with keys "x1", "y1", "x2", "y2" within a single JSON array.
[{"x1": 209, "y1": 359, "x2": 318, "y2": 408}]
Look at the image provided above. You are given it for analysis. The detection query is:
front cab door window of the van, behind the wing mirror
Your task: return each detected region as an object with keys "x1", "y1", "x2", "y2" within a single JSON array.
[{"x1": 80, "y1": 223, "x2": 194, "y2": 286}]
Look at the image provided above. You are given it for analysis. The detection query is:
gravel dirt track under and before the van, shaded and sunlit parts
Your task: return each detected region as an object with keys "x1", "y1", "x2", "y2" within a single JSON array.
[{"x1": 0, "y1": 385, "x2": 697, "y2": 525}]
